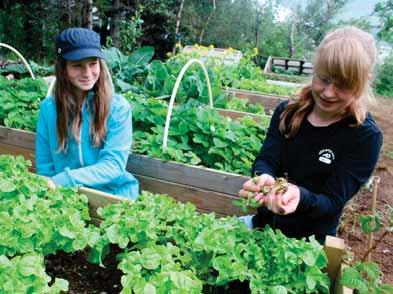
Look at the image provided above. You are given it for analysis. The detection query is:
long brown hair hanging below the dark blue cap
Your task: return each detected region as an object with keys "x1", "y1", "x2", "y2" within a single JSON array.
[{"x1": 55, "y1": 57, "x2": 113, "y2": 152}]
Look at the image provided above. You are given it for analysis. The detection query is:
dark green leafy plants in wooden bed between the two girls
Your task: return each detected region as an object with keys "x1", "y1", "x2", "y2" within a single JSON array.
[{"x1": 125, "y1": 92, "x2": 269, "y2": 175}]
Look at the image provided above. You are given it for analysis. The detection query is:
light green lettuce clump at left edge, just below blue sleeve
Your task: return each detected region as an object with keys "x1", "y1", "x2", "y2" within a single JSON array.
[{"x1": 0, "y1": 155, "x2": 90, "y2": 257}]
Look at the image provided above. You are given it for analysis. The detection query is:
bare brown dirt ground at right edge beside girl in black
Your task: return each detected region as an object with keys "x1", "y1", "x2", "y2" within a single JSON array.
[{"x1": 339, "y1": 97, "x2": 393, "y2": 284}]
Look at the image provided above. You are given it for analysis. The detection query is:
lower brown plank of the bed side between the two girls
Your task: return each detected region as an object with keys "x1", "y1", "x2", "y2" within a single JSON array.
[{"x1": 135, "y1": 174, "x2": 256, "y2": 215}]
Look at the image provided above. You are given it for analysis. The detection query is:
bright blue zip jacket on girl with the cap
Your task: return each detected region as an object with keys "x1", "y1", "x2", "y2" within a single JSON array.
[{"x1": 36, "y1": 92, "x2": 139, "y2": 199}]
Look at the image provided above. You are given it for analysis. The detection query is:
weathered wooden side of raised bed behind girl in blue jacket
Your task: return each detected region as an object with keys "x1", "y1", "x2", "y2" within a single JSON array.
[{"x1": 0, "y1": 126, "x2": 248, "y2": 215}]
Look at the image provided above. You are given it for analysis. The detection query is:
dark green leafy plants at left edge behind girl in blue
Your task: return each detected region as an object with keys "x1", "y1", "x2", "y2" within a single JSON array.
[{"x1": 0, "y1": 75, "x2": 48, "y2": 131}]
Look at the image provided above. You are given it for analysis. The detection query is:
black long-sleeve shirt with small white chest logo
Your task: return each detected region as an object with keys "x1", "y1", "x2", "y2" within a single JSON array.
[{"x1": 252, "y1": 102, "x2": 382, "y2": 243}]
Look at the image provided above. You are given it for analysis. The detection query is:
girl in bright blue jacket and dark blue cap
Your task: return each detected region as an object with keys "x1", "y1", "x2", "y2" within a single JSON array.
[{"x1": 36, "y1": 28, "x2": 139, "y2": 199}]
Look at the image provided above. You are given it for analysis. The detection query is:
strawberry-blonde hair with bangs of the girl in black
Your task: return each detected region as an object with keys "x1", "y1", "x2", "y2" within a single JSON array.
[{"x1": 279, "y1": 27, "x2": 376, "y2": 138}]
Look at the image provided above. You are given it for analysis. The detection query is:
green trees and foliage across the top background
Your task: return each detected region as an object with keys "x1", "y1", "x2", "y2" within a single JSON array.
[{"x1": 0, "y1": 0, "x2": 393, "y2": 95}]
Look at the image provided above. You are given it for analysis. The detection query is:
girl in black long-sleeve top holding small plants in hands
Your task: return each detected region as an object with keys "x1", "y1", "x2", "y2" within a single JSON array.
[{"x1": 239, "y1": 27, "x2": 382, "y2": 243}]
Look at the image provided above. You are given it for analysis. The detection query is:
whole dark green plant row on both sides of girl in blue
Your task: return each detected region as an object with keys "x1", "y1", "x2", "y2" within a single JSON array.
[{"x1": 0, "y1": 77, "x2": 269, "y2": 175}]
